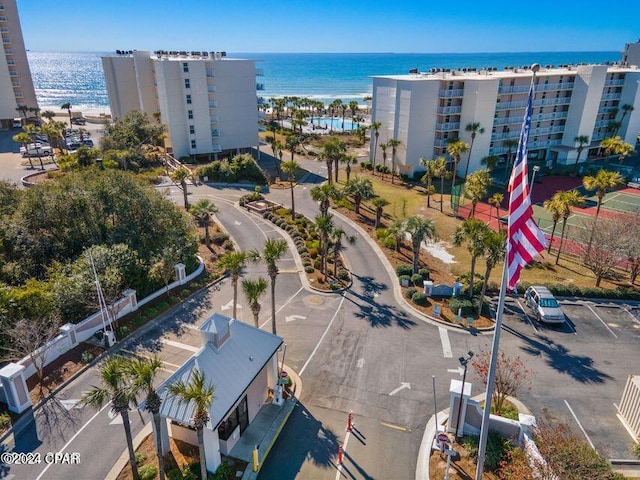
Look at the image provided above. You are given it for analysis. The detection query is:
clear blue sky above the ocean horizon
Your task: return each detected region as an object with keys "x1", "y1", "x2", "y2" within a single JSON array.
[{"x1": 18, "y1": 0, "x2": 640, "y2": 53}]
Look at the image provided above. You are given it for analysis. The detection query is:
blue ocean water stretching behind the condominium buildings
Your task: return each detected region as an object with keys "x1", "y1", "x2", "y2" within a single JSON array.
[{"x1": 28, "y1": 51, "x2": 620, "y2": 113}]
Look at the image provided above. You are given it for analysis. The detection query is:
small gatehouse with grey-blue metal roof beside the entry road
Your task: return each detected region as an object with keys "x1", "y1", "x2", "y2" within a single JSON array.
[{"x1": 152, "y1": 313, "x2": 283, "y2": 472}]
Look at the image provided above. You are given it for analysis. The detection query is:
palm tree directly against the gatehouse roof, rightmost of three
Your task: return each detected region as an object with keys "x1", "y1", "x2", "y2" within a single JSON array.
[{"x1": 169, "y1": 368, "x2": 215, "y2": 480}]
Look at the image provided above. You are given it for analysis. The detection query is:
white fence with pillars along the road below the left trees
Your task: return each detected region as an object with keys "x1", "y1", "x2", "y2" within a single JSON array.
[{"x1": 0, "y1": 257, "x2": 204, "y2": 403}]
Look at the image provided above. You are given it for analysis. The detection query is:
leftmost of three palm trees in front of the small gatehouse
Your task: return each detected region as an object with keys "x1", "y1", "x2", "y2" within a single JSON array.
[{"x1": 80, "y1": 356, "x2": 140, "y2": 480}]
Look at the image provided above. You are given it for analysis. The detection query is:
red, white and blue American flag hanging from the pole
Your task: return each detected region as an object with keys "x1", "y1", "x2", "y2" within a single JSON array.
[{"x1": 507, "y1": 73, "x2": 547, "y2": 290}]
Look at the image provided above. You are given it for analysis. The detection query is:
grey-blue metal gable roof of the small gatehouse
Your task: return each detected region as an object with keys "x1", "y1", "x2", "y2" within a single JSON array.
[{"x1": 158, "y1": 313, "x2": 283, "y2": 428}]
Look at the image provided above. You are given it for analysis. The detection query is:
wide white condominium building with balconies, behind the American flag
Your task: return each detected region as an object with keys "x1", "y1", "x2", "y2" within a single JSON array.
[{"x1": 371, "y1": 57, "x2": 640, "y2": 174}]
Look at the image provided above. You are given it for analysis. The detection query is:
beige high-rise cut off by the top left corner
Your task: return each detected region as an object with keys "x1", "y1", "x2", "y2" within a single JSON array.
[{"x1": 0, "y1": 0, "x2": 38, "y2": 128}]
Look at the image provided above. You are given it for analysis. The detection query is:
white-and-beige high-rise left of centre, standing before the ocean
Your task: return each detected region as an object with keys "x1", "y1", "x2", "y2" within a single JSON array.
[{"x1": 102, "y1": 50, "x2": 260, "y2": 157}]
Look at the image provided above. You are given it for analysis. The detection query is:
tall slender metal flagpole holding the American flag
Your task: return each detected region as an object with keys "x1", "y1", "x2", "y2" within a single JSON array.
[{"x1": 475, "y1": 63, "x2": 540, "y2": 480}]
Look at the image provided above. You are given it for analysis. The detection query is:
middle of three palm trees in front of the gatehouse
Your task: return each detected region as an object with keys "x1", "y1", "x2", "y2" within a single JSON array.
[{"x1": 124, "y1": 355, "x2": 164, "y2": 480}]
